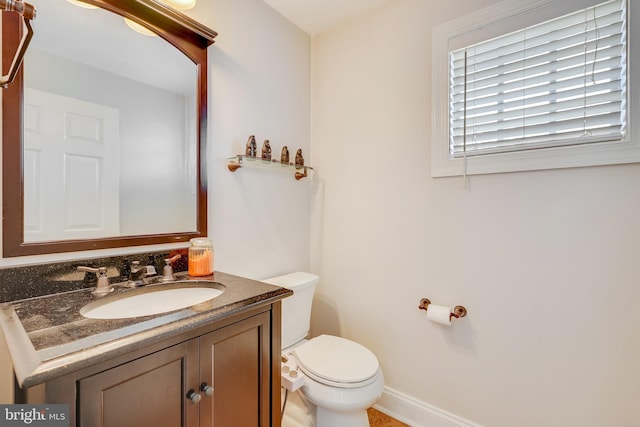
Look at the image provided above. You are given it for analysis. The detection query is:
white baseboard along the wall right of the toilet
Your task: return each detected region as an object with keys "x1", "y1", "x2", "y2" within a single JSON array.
[{"x1": 374, "y1": 387, "x2": 482, "y2": 427}]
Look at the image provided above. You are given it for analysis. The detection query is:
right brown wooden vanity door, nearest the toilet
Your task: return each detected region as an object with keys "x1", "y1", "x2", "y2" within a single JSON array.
[{"x1": 200, "y1": 313, "x2": 271, "y2": 427}]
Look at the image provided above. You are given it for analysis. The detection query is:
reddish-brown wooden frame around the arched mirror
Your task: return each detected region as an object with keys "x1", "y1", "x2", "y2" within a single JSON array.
[{"x1": 2, "y1": 0, "x2": 217, "y2": 257}]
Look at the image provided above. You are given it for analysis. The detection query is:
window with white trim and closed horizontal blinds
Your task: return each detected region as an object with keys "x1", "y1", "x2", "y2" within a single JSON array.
[{"x1": 432, "y1": 0, "x2": 640, "y2": 176}]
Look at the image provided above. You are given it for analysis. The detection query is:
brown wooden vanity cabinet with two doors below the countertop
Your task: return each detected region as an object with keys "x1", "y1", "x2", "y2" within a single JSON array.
[{"x1": 38, "y1": 308, "x2": 280, "y2": 427}]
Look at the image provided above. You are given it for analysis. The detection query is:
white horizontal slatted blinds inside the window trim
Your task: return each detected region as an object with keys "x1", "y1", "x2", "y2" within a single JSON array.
[{"x1": 449, "y1": 0, "x2": 627, "y2": 157}]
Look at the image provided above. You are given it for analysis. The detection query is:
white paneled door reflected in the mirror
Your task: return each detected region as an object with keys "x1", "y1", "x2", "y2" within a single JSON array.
[{"x1": 24, "y1": 88, "x2": 120, "y2": 242}]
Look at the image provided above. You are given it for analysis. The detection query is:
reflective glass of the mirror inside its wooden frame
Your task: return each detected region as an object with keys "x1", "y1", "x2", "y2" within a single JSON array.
[{"x1": 23, "y1": 0, "x2": 198, "y2": 242}]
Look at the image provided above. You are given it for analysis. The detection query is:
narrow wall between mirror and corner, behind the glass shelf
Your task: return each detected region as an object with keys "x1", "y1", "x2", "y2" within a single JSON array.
[{"x1": 208, "y1": 0, "x2": 313, "y2": 278}]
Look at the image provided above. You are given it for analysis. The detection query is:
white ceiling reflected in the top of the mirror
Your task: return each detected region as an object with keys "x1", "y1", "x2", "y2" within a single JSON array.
[{"x1": 30, "y1": 0, "x2": 197, "y2": 95}]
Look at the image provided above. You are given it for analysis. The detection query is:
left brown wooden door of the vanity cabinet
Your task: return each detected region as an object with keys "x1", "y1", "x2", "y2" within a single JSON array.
[{"x1": 78, "y1": 339, "x2": 200, "y2": 427}]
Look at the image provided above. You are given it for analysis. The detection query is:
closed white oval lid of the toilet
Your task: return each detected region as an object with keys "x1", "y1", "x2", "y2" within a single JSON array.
[{"x1": 294, "y1": 335, "x2": 378, "y2": 386}]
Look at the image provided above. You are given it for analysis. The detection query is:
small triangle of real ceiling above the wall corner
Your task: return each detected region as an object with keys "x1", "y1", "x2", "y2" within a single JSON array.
[{"x1": 264, "y1": 0, "x2": 388, "y2": 35}]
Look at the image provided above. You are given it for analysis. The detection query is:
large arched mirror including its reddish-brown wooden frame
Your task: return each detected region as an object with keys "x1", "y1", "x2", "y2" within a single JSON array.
[{"x1": 2, "y1": 0, "x2": 216, "y2": 257}]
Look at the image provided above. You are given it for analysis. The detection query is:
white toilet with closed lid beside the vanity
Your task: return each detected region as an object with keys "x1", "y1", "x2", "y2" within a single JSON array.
[{"x1": 263, "y1": 272, "x2": 384, "y2": 427}]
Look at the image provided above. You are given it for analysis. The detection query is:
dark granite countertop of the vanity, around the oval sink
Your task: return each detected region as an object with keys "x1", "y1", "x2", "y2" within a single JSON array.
[{"x1": 0, "y1": 272, "x2": 293, "y2": 387}]
